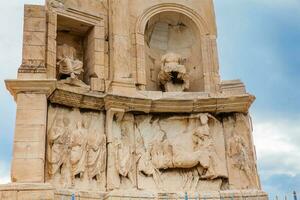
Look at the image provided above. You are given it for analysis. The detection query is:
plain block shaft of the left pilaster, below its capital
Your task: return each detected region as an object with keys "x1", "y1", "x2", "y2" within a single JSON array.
[{"x1": 11, "y1": 93, "x2": 47, "y2": 183}]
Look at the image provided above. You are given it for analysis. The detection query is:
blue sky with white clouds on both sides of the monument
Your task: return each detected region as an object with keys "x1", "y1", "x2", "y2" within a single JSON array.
[{"x1": 0, "y1": 0, "x2": 300, "y2": 199}]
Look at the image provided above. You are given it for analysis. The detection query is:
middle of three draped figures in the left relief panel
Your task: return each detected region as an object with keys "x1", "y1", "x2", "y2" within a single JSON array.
[{"x1": 70, "y1": 121, "x2": 87, "y2": 184}]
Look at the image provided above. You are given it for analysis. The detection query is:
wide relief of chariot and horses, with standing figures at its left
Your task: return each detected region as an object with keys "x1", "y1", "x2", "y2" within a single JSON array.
[{"x1": 108, "y1": 114, "x2": 228, "y2": 191}]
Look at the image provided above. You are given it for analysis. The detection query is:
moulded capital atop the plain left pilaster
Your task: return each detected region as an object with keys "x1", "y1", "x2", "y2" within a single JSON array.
[{"x1": 5, "y1": 80, "x2": 56, "y2": 100}]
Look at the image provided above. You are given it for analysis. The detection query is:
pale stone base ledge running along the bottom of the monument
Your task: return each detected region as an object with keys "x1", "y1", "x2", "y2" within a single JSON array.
[{"x1": 0, "y1": 184, "x2": 268, "y2": 200}]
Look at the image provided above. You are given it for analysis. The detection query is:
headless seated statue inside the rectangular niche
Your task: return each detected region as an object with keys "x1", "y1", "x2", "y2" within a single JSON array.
[{"x1": 57, "y1": 44, "x2": 89, "y2": 88}]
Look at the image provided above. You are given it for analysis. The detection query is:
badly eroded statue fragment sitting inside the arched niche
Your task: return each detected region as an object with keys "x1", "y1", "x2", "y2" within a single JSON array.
[{"x1": 158, "y1": 53, "x2": 189, "y2": 92}]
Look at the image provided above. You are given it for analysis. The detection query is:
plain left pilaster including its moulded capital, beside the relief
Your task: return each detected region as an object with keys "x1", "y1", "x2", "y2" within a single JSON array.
[{"x1": 6, "y1": 80, "x2": 55, "y2": 183}]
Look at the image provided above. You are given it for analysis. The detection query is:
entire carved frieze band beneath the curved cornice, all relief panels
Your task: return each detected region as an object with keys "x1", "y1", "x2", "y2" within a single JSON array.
[{"x1": 47, "y1": 106, "x2": 260, "y2": 192}]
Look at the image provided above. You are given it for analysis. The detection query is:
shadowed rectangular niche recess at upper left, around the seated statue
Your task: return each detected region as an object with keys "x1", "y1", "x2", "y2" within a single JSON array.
[{"x1": 56, "y1": 15, "x2": 95, "y2": 85}]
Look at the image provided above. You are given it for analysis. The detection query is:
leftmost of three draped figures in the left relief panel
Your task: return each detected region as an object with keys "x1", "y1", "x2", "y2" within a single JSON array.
[{"x1": 47, "y1": 117, "x2": 70, "y2": 181}]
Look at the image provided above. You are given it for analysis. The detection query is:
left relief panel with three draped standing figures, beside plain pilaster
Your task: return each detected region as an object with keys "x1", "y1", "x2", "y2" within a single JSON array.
[{"x1": 46, "y1": 106, "x2": 106, "y2": 190}]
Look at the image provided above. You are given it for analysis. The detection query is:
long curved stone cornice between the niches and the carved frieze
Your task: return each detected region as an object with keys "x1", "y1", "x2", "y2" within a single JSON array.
[{"x1": 49, "y1": 84, "x2": 255, "y2": 113}]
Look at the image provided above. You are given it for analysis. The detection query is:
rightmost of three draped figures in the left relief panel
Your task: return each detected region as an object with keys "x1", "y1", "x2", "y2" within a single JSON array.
[{"x1": 87, "y1": 130, "x2": 106, "y2": 182}]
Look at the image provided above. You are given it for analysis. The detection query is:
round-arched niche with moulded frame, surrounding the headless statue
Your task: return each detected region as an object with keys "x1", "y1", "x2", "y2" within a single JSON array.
[{"x1": 136, "y1": 4, "x2": 209, "y2": 92}]
